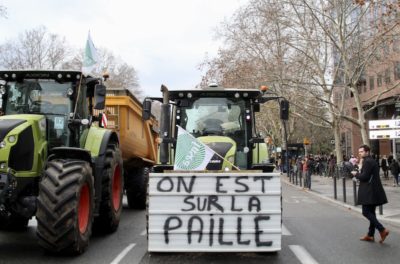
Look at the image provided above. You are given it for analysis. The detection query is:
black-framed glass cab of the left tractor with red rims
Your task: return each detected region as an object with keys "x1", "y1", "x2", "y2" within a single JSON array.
[{"x1": 0, "y1": 71, "x2": 105, "y2": 150}]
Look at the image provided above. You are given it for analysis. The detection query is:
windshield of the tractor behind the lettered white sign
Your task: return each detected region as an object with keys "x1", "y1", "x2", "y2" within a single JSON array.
[{"x1": 180, "y1": 98, "x2": 245, "y2": 139}]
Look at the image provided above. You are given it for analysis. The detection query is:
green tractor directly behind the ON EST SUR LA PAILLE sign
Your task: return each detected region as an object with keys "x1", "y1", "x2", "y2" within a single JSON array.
[{"x1": 143, "y1": 86, "x2": 273, "y2": 172}]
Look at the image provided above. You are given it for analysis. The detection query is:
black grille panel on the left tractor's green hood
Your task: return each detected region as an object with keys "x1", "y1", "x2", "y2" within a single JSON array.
[{"x1": 8, "y1": 126, "x2": 35, "y2": 171}]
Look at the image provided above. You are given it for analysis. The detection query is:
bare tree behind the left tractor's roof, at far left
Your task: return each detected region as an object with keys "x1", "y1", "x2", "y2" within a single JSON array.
[{"x1": 0, "y1": 26, "x2": 70, "y2": 69}]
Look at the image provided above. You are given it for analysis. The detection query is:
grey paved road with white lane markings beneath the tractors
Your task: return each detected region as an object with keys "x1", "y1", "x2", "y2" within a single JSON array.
[{"x1": 0, "y1": 182, "x2": 400, "y2": 264}]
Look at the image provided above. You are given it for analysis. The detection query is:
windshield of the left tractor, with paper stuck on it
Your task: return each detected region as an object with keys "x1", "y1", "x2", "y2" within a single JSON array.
[{"x1": 4, "y1": 80, "x2": 74, "y2": 148}]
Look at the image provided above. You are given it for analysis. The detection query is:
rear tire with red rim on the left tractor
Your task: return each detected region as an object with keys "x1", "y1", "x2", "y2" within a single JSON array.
[{"x1": 94, "y1": 144, "x2": 124, "y2": 233}]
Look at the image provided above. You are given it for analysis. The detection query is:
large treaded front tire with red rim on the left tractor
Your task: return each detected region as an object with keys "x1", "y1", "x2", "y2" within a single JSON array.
[{"x1": 36, "y1": 160, "x2": 94, "y2": 254}]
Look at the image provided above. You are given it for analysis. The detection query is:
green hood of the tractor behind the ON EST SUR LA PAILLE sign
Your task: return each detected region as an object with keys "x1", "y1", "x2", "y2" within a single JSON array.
[{"x1": 197, "y1": 136, "x2": 236, "y2": 170}]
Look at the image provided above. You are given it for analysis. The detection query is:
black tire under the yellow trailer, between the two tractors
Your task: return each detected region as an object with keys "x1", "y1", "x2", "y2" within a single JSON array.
[{"x1": 125, "y1": 167, "x2": 150, "y2": 210}]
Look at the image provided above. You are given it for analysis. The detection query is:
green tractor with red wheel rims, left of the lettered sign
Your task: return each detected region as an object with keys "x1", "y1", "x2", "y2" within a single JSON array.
[{"x1": 0, "y1": 71, "x2": 123, "y2": 254}]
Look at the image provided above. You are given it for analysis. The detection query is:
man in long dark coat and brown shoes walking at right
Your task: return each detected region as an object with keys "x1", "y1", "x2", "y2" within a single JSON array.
[{"x1": 351, "y1": 145, "x2": 389, "y2": 243}]
